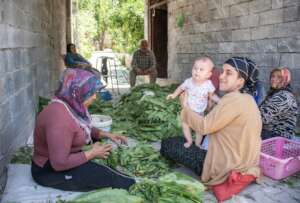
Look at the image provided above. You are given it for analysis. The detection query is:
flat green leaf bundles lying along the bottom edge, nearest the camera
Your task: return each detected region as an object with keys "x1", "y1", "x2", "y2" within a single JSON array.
[{"x1": 63, "y1": 173, "x2": 205, "y2": 203}]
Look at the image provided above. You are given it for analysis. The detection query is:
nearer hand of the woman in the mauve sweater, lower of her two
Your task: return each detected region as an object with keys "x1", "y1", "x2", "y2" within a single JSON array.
[{"x1": 84, "y1": 143, "x2": 112, "y2": 160}]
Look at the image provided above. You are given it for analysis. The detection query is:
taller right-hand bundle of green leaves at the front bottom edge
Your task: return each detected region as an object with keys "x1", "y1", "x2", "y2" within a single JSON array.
[{"x1": 130, "y1": 172, "x2": 205, "y2": 203}]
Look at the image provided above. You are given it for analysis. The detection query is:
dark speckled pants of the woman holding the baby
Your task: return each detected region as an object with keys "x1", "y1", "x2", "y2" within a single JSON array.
[{"x1": 160, "y1": 136, "x2": 206, "y2": 175}]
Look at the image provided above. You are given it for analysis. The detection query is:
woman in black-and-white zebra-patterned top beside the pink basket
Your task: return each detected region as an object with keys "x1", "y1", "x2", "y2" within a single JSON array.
[{"x1": 259, "y1": 68, "x2": 298, "y2": 139}]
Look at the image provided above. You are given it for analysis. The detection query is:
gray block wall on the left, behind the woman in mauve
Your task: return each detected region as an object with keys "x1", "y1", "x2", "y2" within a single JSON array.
[{"x1": 0, "y1": 0, "x2": 67, "y2": 194}]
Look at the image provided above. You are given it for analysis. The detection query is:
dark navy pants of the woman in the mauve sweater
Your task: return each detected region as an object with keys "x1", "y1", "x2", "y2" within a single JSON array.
[{"x1": 31, "y1": 161, "x2": 135, "y2": 192}]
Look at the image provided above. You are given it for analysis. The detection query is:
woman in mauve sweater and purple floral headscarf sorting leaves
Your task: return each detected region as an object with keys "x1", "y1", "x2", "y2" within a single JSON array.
[{"x1": 31, "y1": 68, "x2": 135, "y2": 191}]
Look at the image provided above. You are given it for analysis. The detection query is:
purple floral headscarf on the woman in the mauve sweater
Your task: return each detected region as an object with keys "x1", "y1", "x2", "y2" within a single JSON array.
[{"x1": 52, "y1": 68, "x2": 103, "y2": 143}]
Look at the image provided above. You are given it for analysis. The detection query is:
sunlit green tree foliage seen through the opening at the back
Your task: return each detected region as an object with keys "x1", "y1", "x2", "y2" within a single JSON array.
[{"x1": 75, "y1": 0, "x2": 144, "y2": 57}]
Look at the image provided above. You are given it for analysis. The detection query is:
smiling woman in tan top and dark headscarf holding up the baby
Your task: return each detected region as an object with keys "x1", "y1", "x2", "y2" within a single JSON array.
[{"x1": 161, "y1": 57, "x2": 262, "y2": 201}]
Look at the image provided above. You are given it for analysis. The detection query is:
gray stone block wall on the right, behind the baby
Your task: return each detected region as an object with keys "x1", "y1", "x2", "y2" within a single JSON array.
[{"x1": 168, "y1": 0, "x2": 300, "y2": 98}]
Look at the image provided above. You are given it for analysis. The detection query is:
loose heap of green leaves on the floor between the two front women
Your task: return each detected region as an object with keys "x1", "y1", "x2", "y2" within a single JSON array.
[{"x1": 84, "y1": 144, "x2": 171, "y2": 178}]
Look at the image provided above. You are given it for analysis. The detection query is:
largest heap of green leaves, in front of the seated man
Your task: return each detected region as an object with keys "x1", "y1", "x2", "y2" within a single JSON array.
[{"x1": 89, "y1": 84, "x2": 181, "y2": 142}]
